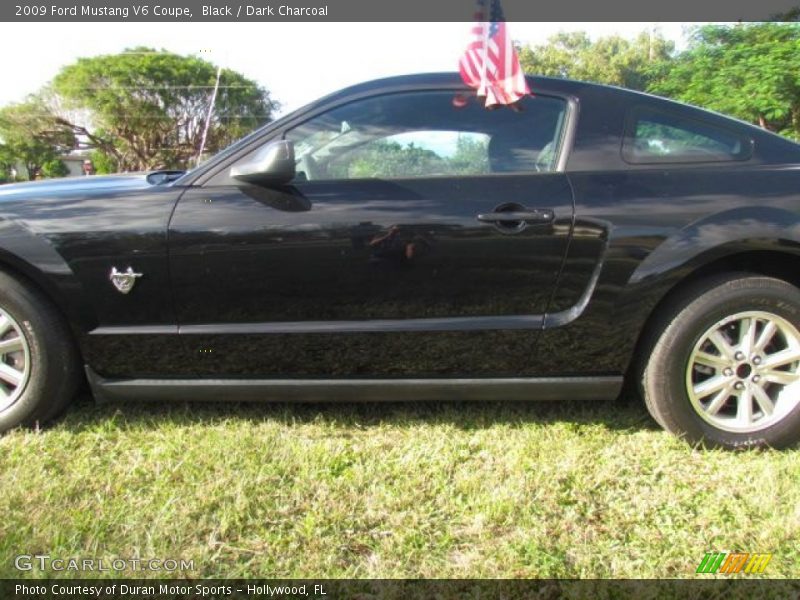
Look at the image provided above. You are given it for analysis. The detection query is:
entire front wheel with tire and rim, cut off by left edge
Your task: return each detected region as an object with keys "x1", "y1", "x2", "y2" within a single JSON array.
[{"x1": 0, "y1": 272, "x2": 80, "y2": 432}]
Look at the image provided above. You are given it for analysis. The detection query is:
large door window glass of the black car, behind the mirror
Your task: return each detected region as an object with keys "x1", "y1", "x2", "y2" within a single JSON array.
[{"x1": 286, "y1": 91, "x2": 566, "y2": 181}]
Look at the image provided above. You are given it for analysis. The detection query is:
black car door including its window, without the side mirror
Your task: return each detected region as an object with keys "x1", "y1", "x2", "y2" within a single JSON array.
[{"x1": 169, "y1": 90, "x2": 573, "y2": 377}]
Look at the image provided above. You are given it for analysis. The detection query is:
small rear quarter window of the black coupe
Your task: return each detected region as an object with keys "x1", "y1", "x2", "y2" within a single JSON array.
[{"x1": 622, "y1": 108, "x2": 753, "y2": 164}]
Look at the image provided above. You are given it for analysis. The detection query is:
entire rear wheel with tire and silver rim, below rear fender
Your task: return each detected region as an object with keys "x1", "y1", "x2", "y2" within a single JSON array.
[{"x1": 641, "y1": 274, "x2": 800, "y2": 448}]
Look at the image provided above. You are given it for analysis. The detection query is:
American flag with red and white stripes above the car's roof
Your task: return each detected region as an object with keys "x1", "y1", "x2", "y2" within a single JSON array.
[{"x1": 459, "y1": 0, "x2": 531, "y2": 107}]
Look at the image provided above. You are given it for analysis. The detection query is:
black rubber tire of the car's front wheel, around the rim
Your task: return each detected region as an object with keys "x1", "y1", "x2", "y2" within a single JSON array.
[{"x1": 0, "y1": 271, "x2": 80, "y2": 433}]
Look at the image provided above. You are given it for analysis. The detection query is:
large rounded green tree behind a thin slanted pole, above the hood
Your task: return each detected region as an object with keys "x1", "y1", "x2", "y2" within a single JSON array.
[{"x1": 48, "y1": 48, "x2": 277, "y2": 171}]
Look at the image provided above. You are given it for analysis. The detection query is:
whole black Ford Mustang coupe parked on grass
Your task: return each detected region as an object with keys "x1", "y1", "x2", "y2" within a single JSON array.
[{"x1": 0, "y1": 74, "x2": 800, "y2": 448}]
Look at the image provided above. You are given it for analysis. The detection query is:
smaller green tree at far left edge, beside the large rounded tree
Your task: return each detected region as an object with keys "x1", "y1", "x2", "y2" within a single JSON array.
[{"x1": 0, "y1": 96, "x2": 75, "y2": 179}]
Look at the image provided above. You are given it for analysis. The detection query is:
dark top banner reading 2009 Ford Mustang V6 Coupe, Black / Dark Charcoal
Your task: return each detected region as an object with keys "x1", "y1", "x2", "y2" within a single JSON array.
[{"x1": 0, "y1": 0, "x2": 800, "y2": 21}]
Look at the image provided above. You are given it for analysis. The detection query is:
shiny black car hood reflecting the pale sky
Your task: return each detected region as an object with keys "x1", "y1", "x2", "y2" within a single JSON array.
[{"x1": 0, "y1": 173, "x2": 152, "y2": 202}]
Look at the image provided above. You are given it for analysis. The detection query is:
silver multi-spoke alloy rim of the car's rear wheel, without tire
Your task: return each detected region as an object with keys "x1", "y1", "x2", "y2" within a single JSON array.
[{"x1": 686, "y1": 311, "x2": 800, "y2": 433}]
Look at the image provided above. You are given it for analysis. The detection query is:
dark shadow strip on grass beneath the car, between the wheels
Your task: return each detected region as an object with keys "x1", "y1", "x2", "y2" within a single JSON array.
[{"x1": 51, "y1": 393, "x2": 659, "y2": 432}]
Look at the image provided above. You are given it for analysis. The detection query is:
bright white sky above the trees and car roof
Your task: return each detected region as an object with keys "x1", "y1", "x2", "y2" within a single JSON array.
[{"x1": 0, "y1": 22, "x2": 693, "y2": 113}]
